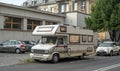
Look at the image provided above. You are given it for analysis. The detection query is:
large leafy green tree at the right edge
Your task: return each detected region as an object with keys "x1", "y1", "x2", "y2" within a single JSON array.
[{"x1": 85, "y1": 0, "x2": 120, "y2": 42}]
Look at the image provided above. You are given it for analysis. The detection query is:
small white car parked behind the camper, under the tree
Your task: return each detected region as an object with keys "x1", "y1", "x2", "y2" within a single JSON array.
[{"x1": 96, "y1": 41, "x2": 120, "y2": 56}]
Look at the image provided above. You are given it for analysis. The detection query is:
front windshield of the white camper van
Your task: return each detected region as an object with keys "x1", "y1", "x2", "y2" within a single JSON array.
[{"x1": 41, "y1": 36, "x2": 57, "y2": 44}]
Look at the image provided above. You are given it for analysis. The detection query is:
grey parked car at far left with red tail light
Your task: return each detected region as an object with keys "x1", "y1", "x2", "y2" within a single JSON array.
[{"x1": 0, "y1": 40, "x2": 26, "y2": 54}]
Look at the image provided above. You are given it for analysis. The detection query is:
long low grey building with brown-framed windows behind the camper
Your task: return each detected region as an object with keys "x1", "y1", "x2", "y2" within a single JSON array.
[{"x1": 0, "y1": 3, "x2": 65, "y2": 42}]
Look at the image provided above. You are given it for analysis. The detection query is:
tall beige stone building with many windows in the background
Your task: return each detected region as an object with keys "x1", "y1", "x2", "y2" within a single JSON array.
[{"x1": 23, "y1": 0, "x2": 95, "y2": 14}]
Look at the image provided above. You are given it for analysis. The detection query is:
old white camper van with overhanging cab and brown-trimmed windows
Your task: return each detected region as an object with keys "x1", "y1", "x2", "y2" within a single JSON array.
[{"x1": 30, "y1": 25, "x2": 94, "y2": 63}]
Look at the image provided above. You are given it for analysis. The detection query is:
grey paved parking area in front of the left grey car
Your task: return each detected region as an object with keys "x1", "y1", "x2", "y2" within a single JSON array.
[{"x1": 0, "y1": 53, "x2": 29, "y2": 66}]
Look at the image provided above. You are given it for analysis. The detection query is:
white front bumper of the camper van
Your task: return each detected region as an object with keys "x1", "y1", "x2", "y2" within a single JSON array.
[{"x1": 30, "y1": 53, "x2": 52, "y2": 61}]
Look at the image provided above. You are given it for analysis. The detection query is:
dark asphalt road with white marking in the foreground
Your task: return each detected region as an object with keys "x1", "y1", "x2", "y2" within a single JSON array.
[{"x1": 0, "y1": 56, "x2": 120, "y2": 71}]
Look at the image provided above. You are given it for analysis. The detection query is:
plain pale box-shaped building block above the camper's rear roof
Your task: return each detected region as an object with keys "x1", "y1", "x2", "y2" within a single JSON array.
[{"x1": 65, "y1": 12, "x2": 89, "y2": 28}]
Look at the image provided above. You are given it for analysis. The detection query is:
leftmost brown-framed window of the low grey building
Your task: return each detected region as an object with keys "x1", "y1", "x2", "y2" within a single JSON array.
[{"x1": 4, "y1": 17, "x2": 22, "y2": 30}]
